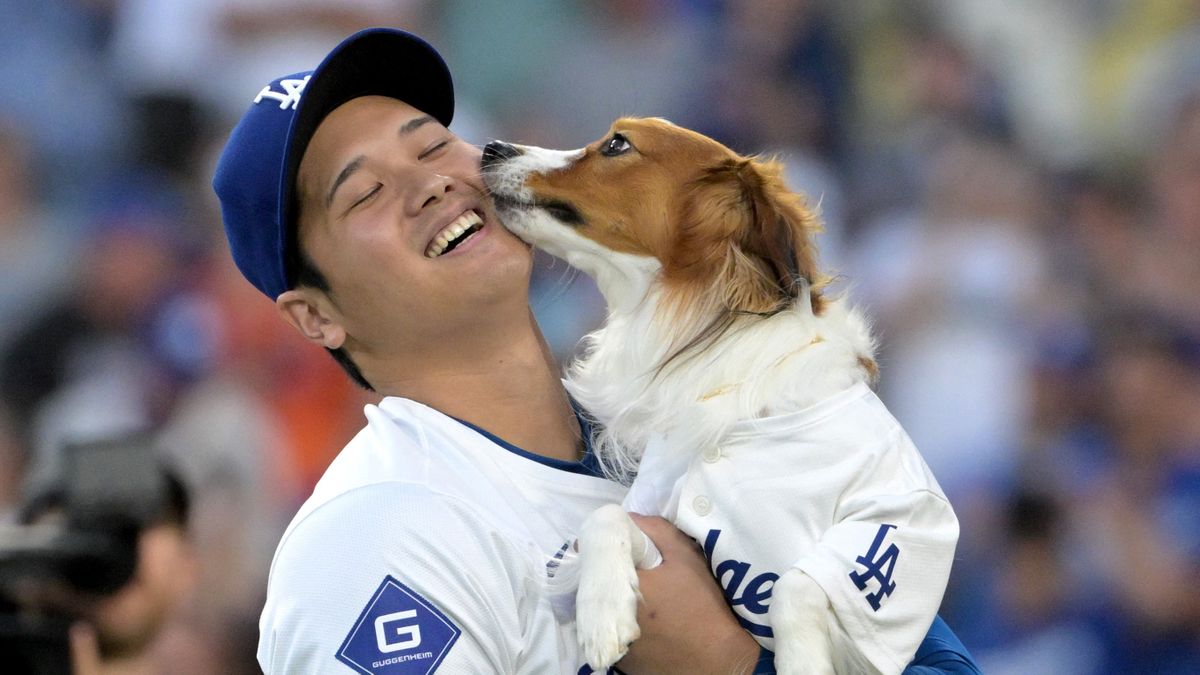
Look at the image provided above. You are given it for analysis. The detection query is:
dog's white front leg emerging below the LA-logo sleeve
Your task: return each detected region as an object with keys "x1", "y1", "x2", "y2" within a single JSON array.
[{"x1": 769, "y1": 569, "x2": 834, "y2": 675}]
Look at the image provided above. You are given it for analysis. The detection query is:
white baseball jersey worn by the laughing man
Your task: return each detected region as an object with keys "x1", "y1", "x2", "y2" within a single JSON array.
[{"x1": 258, "y1": 398, "x2": 624, "y2": 675}]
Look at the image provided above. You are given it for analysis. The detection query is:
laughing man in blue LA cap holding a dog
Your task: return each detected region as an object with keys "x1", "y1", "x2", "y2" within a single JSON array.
[{"x1": 214, "y1": 29, "x2": 974, "y2": 674}]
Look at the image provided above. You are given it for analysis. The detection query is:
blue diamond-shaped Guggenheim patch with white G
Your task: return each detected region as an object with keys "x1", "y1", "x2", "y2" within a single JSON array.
[{"x1": 337, "y1": 575, "x2": 462, "y2": 675}]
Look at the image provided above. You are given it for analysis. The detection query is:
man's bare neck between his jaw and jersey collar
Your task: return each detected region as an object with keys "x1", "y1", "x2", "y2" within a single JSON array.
[{"x1": 372, "y1": 316, "x2": 583, "y2": 461}]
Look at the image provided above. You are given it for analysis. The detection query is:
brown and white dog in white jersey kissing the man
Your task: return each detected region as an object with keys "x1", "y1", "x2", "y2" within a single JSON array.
[{"x1": 484, "y1": 118, "x2": 958, "y2": 674}]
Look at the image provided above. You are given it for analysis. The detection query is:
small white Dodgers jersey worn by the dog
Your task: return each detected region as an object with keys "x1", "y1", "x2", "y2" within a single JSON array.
[{"x1": 625, "y1": 384, "x2": 959, "y2": 673}]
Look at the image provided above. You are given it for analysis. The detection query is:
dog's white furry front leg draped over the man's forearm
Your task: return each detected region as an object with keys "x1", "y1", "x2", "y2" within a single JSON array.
[{"x1": 575, "y1": 504, "x2": 661, "y2": 673}]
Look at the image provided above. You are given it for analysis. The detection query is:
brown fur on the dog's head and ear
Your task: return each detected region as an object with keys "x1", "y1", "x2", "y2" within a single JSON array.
[{"x1": 528, "y1": 118, "x2": 828, "y2": 324}]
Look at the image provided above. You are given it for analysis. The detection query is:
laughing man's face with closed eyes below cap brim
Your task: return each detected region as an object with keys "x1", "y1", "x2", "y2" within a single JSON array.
[{"x1": 296, "y1": 96, "x2": 532, "y2": 354}]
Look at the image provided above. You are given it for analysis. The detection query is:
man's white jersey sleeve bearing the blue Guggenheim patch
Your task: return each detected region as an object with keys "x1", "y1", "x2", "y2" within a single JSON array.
[{"x1": 258, "y1": 483, "x2": 559, "y2": 675}]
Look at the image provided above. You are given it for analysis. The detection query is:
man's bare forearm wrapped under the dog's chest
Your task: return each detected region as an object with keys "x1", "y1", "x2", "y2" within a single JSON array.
[{"x1": 617, "y1": 514, "x2": 758, "y2": 675}]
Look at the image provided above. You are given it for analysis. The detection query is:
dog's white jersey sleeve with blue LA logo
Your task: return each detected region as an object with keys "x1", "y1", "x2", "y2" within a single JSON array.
[{"x1": 794, "y1": 395, "x2": 959, "y2": 673}]
